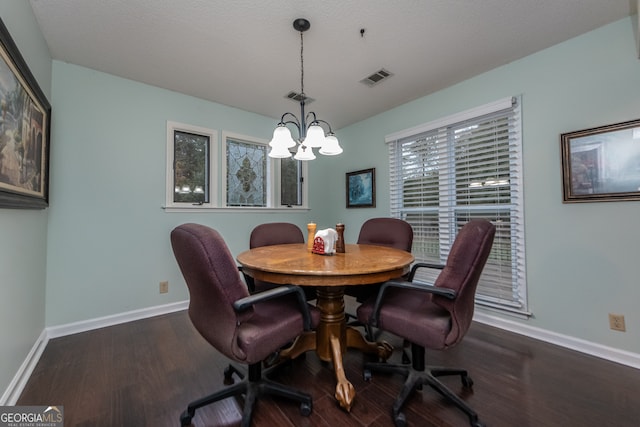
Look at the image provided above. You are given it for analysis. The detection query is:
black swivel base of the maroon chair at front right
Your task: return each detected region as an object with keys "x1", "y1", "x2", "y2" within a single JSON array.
[{"x1": 364, "y1": 344, "x2": 484, "y2": 427}]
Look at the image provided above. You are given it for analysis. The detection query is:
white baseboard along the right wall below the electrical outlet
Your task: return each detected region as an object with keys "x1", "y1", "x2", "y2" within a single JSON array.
[{"x1": 473, "y1": 311, "x2": 640, "y2": 369}]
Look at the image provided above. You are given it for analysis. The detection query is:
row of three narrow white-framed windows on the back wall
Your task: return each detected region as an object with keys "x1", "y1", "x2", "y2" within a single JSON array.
[{"x1": 165, "y1": 121, "x2": 307, "y2": 211}]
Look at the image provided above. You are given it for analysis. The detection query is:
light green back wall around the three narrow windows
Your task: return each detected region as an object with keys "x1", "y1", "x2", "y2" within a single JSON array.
[{"x1": 46, "y1": 61, "x2": 320, "y2": 325}]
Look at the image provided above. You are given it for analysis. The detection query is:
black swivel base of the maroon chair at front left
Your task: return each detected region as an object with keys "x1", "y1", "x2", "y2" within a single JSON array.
[{"x1": 180, "y1": 363, "x2": 313, "y2": 427}]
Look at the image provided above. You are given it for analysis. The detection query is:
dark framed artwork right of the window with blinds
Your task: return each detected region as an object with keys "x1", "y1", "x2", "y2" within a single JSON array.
[{"x1": 560, "y1": 119, "x2": 640, "y2": 203}]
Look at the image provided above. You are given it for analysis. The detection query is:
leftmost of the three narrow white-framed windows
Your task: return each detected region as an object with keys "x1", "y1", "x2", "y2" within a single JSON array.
[{"x1": 166, "y1": 121, "x2": 218, "y2": 207}]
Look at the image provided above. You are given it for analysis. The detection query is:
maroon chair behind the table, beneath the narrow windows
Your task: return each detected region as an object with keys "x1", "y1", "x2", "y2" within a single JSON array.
[{"x1": 245, "y1": 222, "x2": 316, "y2": 301}]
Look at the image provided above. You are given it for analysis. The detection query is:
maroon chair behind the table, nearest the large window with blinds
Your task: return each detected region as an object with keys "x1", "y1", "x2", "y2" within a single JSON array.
[{"x1": 345, "y1": 218, "x2": 413, "y2": 302}]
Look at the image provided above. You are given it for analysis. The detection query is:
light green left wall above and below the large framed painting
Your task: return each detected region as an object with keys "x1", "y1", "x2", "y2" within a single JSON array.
[{"x1": 0, "y1": 0, "x2": 51, "y2": 402}]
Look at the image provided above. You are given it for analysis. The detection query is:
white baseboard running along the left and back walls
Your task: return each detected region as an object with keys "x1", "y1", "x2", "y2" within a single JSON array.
[{"x1": 0, "y1": 301, "x2": 189, "y2": 406}]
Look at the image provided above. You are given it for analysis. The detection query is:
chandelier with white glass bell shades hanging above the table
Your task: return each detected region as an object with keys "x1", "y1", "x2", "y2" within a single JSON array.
[{"x1": 269, "y1": 18, "x2": 342, "y2": 160}]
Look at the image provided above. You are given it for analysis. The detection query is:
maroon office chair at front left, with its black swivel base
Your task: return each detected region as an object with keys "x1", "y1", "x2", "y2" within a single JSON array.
[{"x1": 171, "y1": 224, "x2": 320, "y2": 426}]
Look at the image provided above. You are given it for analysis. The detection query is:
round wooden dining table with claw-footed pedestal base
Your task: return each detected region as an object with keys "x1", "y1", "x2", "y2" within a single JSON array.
[{"x1": 237, "y1": 243, "x2": 414, "y2": 411}]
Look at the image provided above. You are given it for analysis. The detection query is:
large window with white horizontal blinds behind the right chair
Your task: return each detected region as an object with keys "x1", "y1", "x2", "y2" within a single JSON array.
[{"x1": 386, "y1": 98, "x2": 528, "y2": 315}]
